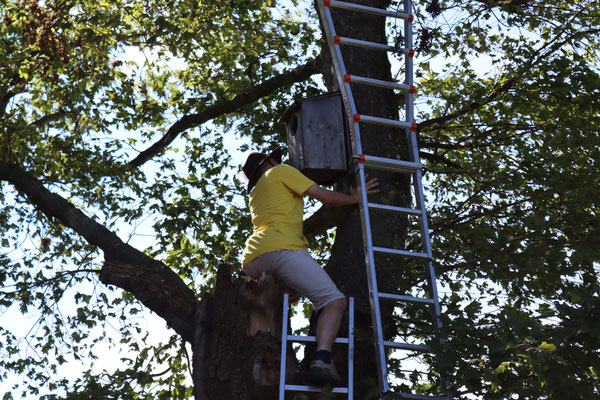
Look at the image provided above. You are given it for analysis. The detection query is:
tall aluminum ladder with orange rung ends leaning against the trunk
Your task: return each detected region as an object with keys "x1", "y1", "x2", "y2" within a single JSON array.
[{"x1": 317, "y1": 0, "x2": 452, "y2": 400}]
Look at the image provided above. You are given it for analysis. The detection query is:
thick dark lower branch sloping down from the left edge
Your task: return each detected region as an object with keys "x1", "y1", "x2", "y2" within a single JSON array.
[{"x1": 0, "y1": 162, "x2": 198, "y2": 342}]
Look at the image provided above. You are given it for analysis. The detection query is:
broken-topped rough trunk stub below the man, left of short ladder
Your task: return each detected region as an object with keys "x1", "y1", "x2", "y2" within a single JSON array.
[{"x1": 193, "y1": 264, "x2": 298, "y2": 400}]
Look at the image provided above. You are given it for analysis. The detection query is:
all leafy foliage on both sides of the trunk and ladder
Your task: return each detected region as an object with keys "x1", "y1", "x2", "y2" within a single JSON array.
[{"x1": 0, "y1": 0, "x2": 600, "y2": 399}]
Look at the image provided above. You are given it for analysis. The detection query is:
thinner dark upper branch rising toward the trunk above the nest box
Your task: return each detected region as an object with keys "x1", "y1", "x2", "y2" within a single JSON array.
[{"x1": 129, "y1": 56, "x2": 321, "y2": 167}]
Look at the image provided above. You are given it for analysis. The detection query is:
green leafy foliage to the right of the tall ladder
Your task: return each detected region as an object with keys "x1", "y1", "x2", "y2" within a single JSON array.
[{"x1": 421, "y1": 2, "x2": 600, "y2": 399}]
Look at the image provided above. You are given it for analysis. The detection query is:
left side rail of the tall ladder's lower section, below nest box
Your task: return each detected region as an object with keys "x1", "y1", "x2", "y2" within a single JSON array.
[{"x1": 358, "y1": 163, "x2": 389, "y2": 392}]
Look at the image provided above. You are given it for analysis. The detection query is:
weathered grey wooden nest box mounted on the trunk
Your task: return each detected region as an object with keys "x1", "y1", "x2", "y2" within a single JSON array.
[{"x1": 279, "y1": 92, "x2": 348, "y2": 185}]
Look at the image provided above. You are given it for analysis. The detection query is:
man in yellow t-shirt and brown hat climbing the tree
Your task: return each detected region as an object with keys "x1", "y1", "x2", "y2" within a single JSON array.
[{"x1": 242, "y1": 147, "x2": 378, "y2": 386}]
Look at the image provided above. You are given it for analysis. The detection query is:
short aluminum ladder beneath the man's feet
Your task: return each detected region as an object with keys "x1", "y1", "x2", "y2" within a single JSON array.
[{"x1": 279, "y1": 293, "x2": 354, "y2": 400}]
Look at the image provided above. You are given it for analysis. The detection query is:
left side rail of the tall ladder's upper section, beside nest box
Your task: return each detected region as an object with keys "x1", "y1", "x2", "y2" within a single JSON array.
[{"x1": 317, "y1": 0, "x2": 362, "y2": 155}]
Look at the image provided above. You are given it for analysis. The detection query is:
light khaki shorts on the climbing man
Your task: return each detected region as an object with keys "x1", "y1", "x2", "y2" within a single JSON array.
[{"x1": 244, "y1": 250, "x2": 345, "y2": 311}]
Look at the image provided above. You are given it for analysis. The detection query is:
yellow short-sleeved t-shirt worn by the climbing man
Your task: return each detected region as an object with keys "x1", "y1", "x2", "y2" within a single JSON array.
[{"x1": 242, "y1": 164, "x2": 315, "y2": 265}]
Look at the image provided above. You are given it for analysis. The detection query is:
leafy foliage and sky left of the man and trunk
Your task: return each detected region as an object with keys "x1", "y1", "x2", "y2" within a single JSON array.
[{"x1": 0, "y1": 0, "x2": 315, "y2": 398}]
